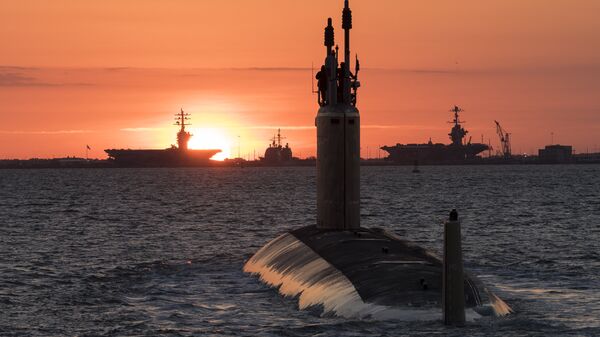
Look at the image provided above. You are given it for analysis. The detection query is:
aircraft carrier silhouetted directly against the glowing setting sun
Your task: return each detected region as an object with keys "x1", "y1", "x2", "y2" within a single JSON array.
[{"x1": 104, "y1": 109, "x2": 221, "y2": 167}]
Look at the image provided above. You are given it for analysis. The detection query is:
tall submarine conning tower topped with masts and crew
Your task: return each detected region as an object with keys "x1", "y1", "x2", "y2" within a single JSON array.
[{"x1": 315, "y1": 0, "x2": 360, "y2": 230}]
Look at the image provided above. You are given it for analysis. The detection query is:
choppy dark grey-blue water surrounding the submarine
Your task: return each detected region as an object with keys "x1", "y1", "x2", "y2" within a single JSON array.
[{"x1": 0, "y1": 165, "x2": 600, "y2": 336}]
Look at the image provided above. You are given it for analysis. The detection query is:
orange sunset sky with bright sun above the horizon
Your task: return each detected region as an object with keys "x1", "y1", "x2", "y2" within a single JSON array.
[{"x1": 0, "y1": 0, "x2": 600, "y2": 159}]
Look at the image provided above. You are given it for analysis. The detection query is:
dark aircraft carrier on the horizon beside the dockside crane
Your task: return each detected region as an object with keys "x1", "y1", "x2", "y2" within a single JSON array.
[{"x1": 381, "y1": 106, "x2": 489, "y2": 165}]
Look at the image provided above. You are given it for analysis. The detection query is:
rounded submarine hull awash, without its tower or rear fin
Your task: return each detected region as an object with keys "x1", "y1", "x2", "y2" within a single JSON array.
[{"x1": 244, "y1": 226, "x2": 512, "y2": 320}]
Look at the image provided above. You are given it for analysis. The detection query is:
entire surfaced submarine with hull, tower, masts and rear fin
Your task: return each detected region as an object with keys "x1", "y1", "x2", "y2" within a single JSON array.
[{"x1": 243, "y1": 0, "x2": 512, "y2": 325}]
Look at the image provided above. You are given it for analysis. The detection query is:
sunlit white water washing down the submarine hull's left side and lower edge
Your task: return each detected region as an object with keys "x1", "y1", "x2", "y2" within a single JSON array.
[{"x1": 244, "y1": 234, "x2": 481, "y2": 321}]
